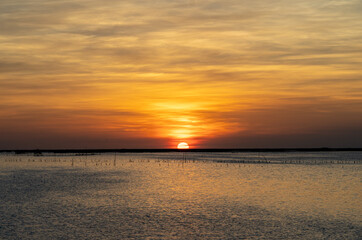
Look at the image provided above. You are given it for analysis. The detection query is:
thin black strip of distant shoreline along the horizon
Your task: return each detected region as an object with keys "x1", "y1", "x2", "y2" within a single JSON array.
[{"x1": 0, "y1": 148, "x2": 362, "y2": 154}]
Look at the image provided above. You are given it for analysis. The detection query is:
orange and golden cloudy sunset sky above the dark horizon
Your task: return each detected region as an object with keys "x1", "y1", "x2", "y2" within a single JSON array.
[{"x1": 0, "y1": 0, "x2": 362, "y2": 149}]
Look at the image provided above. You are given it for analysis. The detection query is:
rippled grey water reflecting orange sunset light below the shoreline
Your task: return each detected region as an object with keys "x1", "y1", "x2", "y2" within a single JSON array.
[{"x1": 0, "y1": 152, "x2": 362, "y2": 239}]
